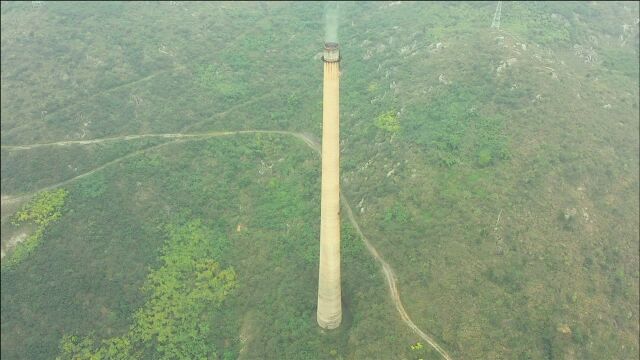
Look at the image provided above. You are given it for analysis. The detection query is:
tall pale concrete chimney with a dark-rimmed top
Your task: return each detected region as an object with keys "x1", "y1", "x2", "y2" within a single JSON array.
[{"x1": 317, "y1": 42, "x2": 342, "y2": 329}]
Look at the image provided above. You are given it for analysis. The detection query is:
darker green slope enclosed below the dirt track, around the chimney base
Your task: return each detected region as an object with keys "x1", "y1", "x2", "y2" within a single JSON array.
[{"x1": 2, "y1": 135, "x2": 413, "y2": 359}]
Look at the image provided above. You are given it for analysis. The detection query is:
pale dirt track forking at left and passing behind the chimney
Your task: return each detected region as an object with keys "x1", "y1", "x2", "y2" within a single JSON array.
[{"x1": 1, "y1": 130, "x2": 452, "y2": 360}]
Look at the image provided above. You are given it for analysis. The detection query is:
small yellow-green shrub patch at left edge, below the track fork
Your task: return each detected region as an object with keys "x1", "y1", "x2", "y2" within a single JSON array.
[{"x1": 2, "y1": 189, "x2": 68, "y2": 270}]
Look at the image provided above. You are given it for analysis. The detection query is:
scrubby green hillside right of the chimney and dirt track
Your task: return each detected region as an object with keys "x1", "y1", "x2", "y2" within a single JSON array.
[{"x1": 343, "y1": 4, "x2": 638, "y2": 358}]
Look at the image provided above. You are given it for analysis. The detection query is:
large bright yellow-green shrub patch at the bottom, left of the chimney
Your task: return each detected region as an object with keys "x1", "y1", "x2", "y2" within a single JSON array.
[{"x1": 57, "y1": 220, "x2": 236, "y2": 360}]
